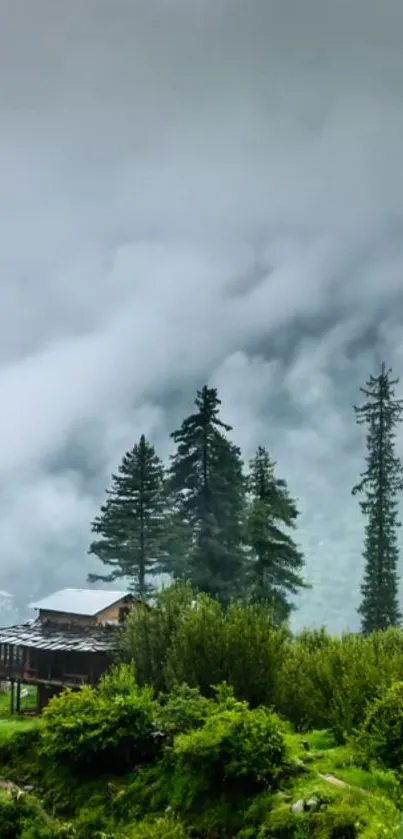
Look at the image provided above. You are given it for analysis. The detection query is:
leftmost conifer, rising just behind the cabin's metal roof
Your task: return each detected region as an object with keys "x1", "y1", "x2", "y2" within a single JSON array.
[{"x1": 88, "y1": 434, "x2": 168, "y2": 596}]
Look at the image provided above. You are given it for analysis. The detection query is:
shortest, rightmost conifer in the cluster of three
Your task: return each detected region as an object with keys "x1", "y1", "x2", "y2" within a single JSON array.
[{"x1": 246, "y1": 446, "x2": 307, "y2": 622}]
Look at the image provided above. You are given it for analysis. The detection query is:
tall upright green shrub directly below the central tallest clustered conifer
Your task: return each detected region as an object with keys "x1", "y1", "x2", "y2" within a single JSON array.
[{"x1": 166, "y1": 596, "x2": 287, "y2": 707}]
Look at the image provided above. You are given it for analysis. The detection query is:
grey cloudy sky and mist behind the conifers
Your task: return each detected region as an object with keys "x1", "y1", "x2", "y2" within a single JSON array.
[{"x1": 0, "y1": 0, "x2": 403, "y2": 632}]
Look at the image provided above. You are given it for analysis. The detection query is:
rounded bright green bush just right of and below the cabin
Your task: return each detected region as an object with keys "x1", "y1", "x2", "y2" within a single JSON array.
[{"x1": 41, "y1": 666, "x2": 158, "y2": 771}]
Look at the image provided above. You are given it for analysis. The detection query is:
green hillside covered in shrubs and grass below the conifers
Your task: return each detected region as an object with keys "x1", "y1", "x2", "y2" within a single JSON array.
[{"x1": 0, "y1": 585, "x2": 403, "y2": 839}]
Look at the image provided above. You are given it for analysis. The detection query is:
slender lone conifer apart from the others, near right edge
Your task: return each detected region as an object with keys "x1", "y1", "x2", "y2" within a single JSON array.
[{"x1": 352, "y1": 364, "x2": 403, "y2": 633}]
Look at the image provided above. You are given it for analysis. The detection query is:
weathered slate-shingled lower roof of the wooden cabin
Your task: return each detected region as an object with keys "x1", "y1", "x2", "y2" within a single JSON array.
[{"x1": 0, "y1": 619, "x2": 117, "y2": 653}]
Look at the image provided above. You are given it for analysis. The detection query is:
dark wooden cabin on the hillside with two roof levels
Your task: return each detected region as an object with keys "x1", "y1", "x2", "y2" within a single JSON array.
[{"x1": 0, "y1": 589, "x2": 134, "y2": 713}]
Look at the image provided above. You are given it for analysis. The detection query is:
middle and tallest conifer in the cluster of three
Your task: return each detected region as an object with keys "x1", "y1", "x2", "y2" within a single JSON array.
[{"x1": 169, "y1": 386, "x2": 245, "y2": 602}]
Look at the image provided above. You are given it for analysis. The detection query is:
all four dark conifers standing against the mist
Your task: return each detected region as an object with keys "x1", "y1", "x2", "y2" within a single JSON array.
[{"x1": 89, "y1": 363, "x2": 403, "y2": 632}]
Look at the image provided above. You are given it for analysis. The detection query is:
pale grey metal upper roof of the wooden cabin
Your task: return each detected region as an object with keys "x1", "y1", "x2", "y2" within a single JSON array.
[{"x1": 31, "y1": 588, "x2": 129, "y2": 617}]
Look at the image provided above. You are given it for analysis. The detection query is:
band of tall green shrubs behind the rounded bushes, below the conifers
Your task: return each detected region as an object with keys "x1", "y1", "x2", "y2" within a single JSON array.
[{"x1": 124, "y1": 584, "x2": 403, "y2": 742}]
